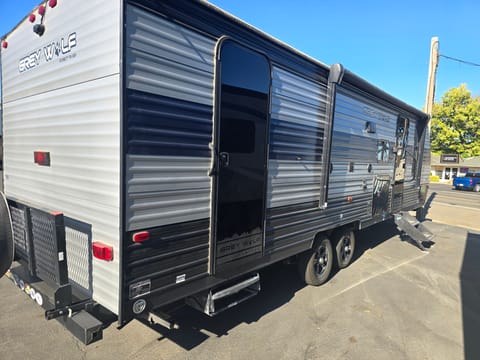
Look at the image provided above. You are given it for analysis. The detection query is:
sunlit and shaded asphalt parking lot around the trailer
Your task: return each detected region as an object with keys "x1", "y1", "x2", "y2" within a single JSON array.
[{"x1": 0, "y1": 185, "x2": 480, "y2": 360}]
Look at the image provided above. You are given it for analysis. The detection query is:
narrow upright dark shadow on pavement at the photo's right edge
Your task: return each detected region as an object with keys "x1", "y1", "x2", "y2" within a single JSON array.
[{"x1": 460, "y1": 232, "x2": 480, "y2": 360}]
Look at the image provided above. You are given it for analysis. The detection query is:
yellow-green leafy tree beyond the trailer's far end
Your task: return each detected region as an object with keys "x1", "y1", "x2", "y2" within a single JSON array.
[{"x1": 431, "y1": 84, "x2": 480, "y2": 157}]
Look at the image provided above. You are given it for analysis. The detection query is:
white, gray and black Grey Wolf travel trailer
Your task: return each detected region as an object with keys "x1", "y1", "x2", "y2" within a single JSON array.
[{"x1": 0, "y1": 0, "x2": 430, "y2": 343}]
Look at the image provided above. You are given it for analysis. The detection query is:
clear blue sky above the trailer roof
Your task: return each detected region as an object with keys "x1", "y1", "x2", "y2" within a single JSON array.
[{"x1": 0, "y1": 0, "x2": 480, "y2": 108}]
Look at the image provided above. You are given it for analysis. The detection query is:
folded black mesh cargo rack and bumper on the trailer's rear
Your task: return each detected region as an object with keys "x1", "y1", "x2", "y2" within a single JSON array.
[{"x1": 6, "y1": 201, "x2": 103, "y2": 344}]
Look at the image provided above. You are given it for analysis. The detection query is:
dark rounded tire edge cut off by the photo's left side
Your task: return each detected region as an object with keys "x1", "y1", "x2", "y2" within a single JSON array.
[{"x1": 0, "y1": 192, "x2": 14, "y2": 278}]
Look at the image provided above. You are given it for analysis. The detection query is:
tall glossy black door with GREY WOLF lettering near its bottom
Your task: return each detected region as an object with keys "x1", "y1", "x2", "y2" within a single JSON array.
[{"x1": 214, "y1": 40, "x2": 270, "y2": 273}]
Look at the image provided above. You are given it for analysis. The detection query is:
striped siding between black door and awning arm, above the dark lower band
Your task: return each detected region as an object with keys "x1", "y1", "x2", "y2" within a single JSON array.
[{"x1": 267, "y1": 67, "x2": 327, "y2": 208}]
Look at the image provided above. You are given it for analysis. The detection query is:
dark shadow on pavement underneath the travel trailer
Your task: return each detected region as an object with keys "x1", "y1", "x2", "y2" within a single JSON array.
[{"x1": 144, "y1": 221, "x2": 398, "y2": 350}]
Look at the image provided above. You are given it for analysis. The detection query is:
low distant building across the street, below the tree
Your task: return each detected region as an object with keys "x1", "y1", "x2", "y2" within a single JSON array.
[{"x1": 431, "y1": 154, "x2": 480, "y2": 182}]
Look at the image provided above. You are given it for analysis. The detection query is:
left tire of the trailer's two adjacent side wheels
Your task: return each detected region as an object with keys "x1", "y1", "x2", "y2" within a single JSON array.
[{"x1": 298, "y1": 237, "x2": 334, "y2": 286}]
